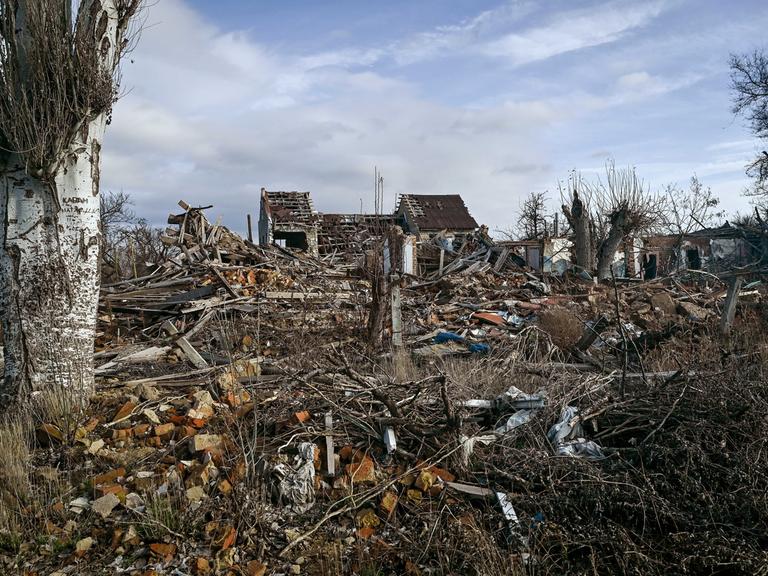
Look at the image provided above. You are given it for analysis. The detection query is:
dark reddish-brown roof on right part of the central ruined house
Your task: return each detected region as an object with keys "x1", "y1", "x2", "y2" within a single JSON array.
[{"x1": 396, "y1": 194, "x2": 478, "y2": 240}]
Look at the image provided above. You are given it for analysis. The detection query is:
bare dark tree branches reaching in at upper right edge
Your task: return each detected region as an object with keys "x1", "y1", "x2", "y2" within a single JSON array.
[{"x1": 729, "y1": 50, "x2": 768, "y2": 204}]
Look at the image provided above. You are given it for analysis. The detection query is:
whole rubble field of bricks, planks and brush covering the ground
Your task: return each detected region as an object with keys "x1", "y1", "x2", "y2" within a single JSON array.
[{"x1": 0, "y1": 205, "x2": 768, "y2": 576}]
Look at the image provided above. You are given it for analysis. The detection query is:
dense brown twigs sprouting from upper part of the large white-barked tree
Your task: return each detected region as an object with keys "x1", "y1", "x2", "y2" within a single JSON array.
[{"x1": 0, "y1": 0, "x2": 141, "y2": 181}]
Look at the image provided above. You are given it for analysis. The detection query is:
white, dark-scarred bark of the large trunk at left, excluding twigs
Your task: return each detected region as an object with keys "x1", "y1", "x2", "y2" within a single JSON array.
[{"x1": 0, "y1": 0, "x2": 131, "y2": 407}]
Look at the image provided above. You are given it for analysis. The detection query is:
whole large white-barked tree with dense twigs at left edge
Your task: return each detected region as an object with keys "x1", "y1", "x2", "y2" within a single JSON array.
[{"x1": 0, "y1": 0, "x2": 141, "y2": 407}]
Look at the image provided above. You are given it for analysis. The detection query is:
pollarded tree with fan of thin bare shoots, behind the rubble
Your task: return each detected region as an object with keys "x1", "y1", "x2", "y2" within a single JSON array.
[{"x1": 561, "y1": 162, "x2": 663, "y2": 280}]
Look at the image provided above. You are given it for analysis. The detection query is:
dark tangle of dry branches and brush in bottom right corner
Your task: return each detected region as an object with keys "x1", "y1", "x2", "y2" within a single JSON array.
[{"x1": 476, "y1": 336, "x2": 768, "y2": 574}]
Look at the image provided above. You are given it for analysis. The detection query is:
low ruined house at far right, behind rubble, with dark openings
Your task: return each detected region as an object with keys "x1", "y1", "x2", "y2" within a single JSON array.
[{"x1": 641, "y1": 222, "x2": 762, "y2": 280}]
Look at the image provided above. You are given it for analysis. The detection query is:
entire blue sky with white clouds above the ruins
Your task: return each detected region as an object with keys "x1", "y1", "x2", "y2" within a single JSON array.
[{"x1": 102, "y1": 0, "x2": 768, "y2": 231}]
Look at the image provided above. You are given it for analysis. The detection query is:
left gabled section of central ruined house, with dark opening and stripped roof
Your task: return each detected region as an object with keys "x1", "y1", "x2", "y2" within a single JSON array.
[{"x1": 259, "y1": 188, "x2": 318, "y2": 255}]
